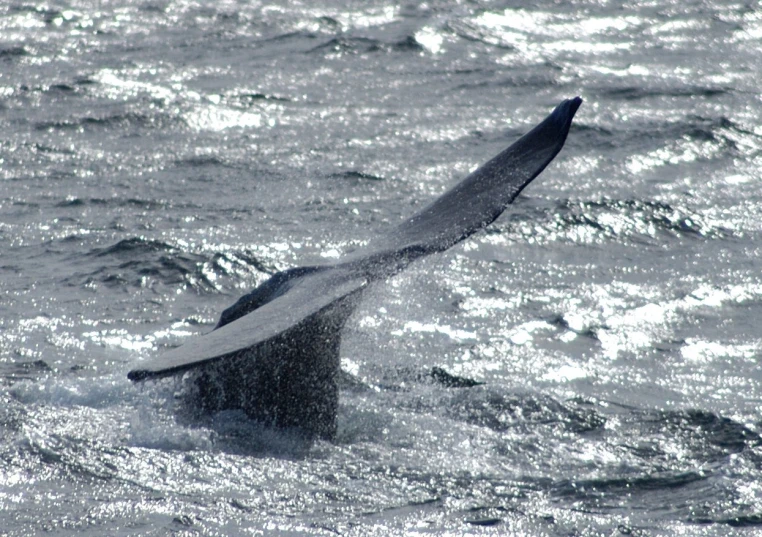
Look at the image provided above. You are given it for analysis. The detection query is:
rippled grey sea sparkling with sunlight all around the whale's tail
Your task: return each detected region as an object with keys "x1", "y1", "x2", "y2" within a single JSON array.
[{"x1": 0, "y1": 0, "x2": 762, "y2": 536}]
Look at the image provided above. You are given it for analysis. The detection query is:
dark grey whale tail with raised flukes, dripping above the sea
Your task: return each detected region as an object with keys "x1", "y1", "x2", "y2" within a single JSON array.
[{"x1": 128, "y1": 97, "x2": 582, "y2": 439}]
